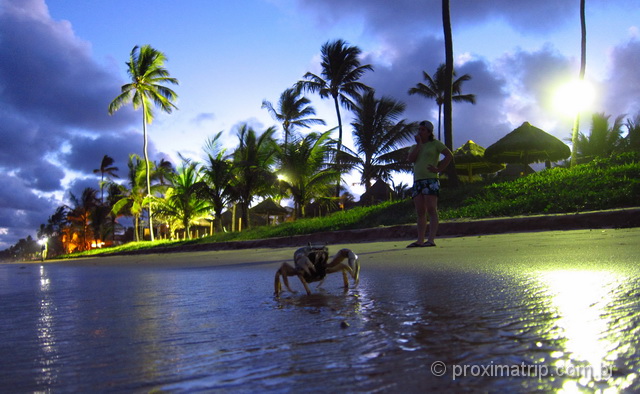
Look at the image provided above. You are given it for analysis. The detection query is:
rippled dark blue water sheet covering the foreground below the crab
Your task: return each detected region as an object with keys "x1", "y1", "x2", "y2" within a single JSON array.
[{"x1": 0, "y1": 263, "x2": 640, "y2": 392}]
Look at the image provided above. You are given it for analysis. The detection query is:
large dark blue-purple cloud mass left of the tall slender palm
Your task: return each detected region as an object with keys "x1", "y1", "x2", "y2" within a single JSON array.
[{"x1": 0, "y1": 0, "x2": 142, "y2": 249}]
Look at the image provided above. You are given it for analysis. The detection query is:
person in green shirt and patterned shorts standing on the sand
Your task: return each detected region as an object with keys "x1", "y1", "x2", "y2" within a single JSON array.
[{"x1": 407, "y1": 120, "x2": 453, "y2": 248}]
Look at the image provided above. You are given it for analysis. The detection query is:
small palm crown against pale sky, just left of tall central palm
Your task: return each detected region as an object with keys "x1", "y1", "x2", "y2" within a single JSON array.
[{"x1": 262, "y1": 87, "x2": 326, "y2": 147}]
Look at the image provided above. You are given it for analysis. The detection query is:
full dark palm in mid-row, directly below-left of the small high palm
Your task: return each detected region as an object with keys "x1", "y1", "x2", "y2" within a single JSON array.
[{"x1": 233, "y1": 124, "x2": 277, "y2": 228}]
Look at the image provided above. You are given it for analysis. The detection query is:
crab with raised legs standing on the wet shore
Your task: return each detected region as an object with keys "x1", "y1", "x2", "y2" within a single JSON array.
[{"x1": 274, "y1": 243, "x2": 360, "y2": 296}]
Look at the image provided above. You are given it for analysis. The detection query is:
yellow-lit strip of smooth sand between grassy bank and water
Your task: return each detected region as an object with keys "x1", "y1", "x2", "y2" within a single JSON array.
[{"x1": 57, "y1": 228, "x2": 640, "y2": 274}]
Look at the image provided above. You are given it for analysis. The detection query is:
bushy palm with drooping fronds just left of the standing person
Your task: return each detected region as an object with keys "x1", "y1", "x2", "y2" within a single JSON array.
[{"x1": 345, "y1": 90, "x2": 416, "y2": 191}]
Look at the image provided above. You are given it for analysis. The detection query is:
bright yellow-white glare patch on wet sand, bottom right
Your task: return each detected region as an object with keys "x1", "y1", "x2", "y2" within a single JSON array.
[{"x1": 540, "y1": 270, "x2": 639, "y2": 390}]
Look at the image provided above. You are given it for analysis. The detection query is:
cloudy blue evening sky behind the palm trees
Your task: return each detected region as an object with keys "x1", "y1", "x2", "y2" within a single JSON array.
[{"x1": 0, "y1": 0, "x2": 640, "y2": 249}]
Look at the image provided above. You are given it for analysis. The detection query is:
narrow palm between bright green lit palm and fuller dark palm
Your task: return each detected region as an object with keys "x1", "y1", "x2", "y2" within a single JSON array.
[{"x1": 203, "y1": 132, "x2": 235, "y2": 232}]
